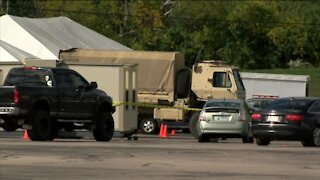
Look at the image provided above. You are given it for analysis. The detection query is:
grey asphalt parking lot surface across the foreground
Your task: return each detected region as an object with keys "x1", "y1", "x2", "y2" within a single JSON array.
[{"x1": 0, "y1": 132, "x2": 320, "y2": 180}]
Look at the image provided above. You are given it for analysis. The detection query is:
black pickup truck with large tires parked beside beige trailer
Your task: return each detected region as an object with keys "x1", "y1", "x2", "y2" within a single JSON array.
[{"x1": 0, "y1": 67, "x2": 115, "y2": 141}]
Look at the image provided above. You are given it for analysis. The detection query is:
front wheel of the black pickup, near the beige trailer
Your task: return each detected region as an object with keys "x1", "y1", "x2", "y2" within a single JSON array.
[{"x1": 92, "y1": 112, "x2": 114, "y2": 142}]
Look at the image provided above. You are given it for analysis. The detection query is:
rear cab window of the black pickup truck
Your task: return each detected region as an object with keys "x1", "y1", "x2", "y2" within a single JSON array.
[{"x1": 4, "y1": 68, "x2": 52, "y2": 86}]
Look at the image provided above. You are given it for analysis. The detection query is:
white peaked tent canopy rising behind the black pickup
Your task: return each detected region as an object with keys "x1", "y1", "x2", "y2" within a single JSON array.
[{"x1": 0, "y1": 15, "x2": 131, "y2": 62}]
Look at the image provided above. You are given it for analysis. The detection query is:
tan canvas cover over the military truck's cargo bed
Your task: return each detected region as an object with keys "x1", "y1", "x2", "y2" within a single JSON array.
[{"x1": 59, "y1": 48, "x2": 185, "y2": 94}]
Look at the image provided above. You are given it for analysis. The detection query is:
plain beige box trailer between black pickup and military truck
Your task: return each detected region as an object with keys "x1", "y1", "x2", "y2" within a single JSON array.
[{"x1": 58, "y1": 62, "x2": 138, "y2": 134}]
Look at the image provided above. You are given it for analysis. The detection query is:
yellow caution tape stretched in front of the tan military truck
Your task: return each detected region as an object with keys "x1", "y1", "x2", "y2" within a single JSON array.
[{"x1": 113, "y1": 101, "x2": 201, "y2": 111}]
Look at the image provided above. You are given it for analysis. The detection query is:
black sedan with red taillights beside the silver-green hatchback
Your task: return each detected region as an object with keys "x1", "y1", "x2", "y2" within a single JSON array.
[{"x1": 251, "y1": 97, "x2": 320, "y2": 147}]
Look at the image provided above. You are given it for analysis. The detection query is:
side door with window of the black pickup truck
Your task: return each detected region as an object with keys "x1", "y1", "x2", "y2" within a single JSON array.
[{"x1": 53, "y1": 69, "x2": 96, "y2": 119}]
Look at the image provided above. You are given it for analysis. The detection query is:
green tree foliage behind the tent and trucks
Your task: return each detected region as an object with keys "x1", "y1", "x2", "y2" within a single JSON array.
[{"x1": 0, "y1": 0, "x2": 320, "y2": 69}]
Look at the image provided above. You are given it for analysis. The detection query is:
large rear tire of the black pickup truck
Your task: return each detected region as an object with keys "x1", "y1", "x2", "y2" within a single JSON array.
[{"x1": 28, "y1": 110, "x2": 58, "y2": 141}]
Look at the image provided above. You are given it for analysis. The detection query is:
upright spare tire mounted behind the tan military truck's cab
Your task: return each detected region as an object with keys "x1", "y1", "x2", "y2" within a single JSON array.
[{"x1": 176, "y1": 68, "x2": 191, "y2": 98}]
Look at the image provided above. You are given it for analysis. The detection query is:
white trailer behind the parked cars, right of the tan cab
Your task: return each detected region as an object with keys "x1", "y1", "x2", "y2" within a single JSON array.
[{"x1": 240, "y1": 72, "x2": 309, "y2": 99}]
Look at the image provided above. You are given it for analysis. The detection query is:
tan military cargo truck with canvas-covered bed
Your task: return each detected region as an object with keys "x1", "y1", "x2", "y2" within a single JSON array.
[{"x1": 59, "y1": 49, "x2": 245, "y2": 134}]
